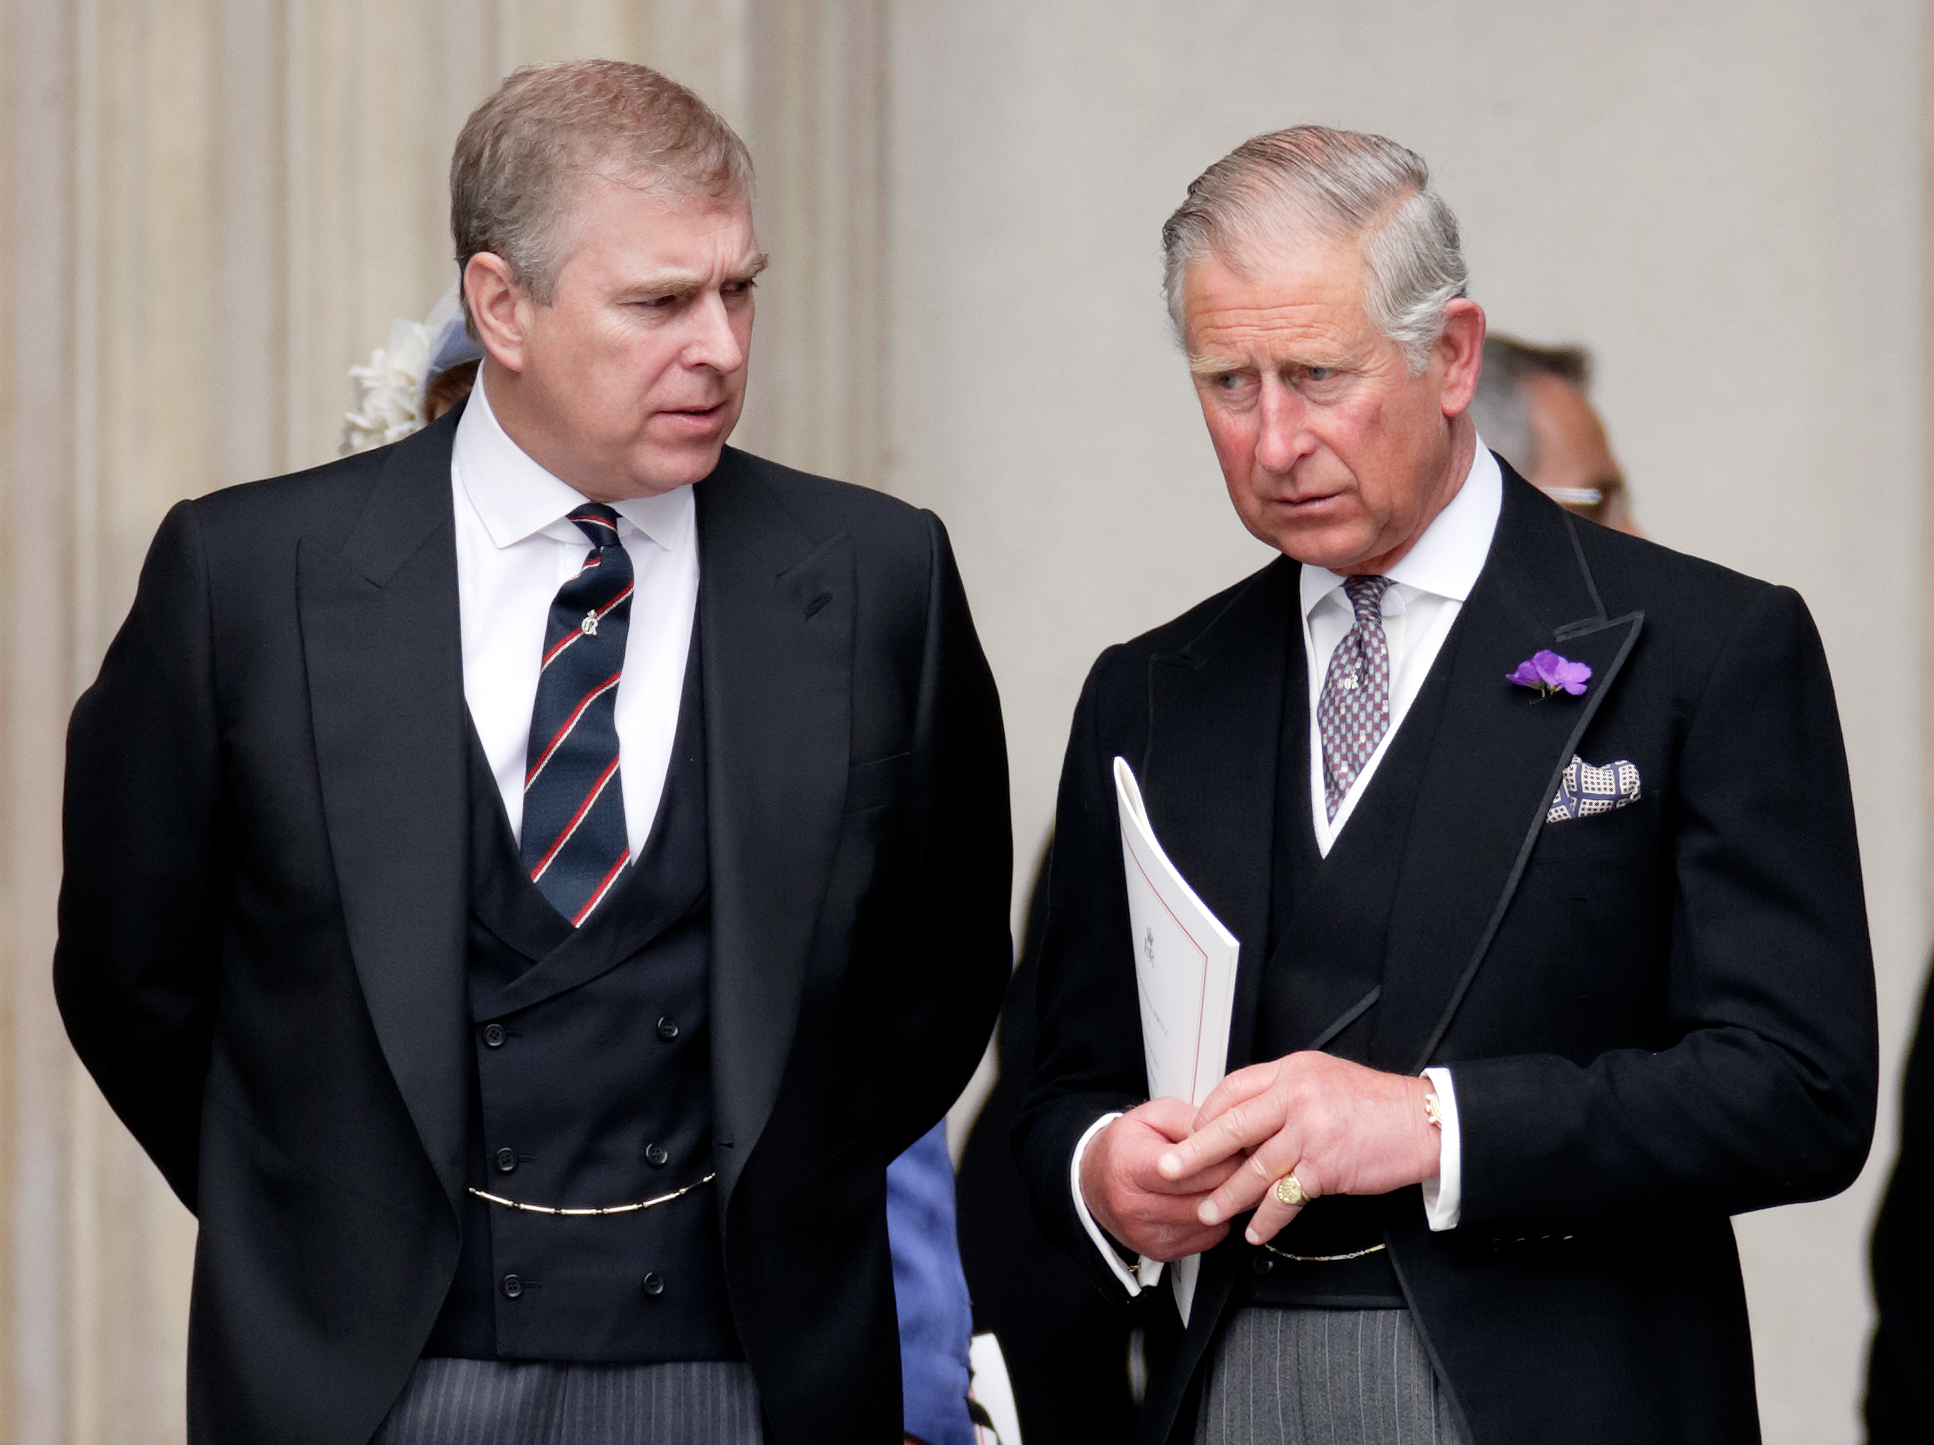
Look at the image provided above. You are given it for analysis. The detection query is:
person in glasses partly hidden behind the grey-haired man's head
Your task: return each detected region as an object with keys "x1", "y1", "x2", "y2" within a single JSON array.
[{"x1": 1470, "y1": 333, "x2": 1638, "y2": 536}]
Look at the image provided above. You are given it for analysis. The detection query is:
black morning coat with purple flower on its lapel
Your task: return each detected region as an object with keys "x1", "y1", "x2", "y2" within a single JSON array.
[{"x1": 1015, "y1": 468, "x2": 1876, "y2": 1445}]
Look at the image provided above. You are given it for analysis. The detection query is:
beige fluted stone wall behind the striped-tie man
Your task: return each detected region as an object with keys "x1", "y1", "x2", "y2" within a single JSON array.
[{"x1": 0, "y1": 0, "x2": 886, "y2": 1445}]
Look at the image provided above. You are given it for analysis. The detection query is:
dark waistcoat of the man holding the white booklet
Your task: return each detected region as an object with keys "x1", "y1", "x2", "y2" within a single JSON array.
[{"x1": 1249, "y1": 638, "x2": 1452, "y2": 1308}]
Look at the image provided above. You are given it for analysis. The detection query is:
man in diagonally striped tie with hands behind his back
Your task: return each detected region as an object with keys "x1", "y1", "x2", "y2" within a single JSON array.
[{"x1": 56, "y1": 62, "x2": 1010, "y2": 1445}]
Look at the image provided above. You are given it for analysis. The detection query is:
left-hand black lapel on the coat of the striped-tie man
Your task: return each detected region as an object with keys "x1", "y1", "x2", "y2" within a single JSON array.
[{"x1": 296, "y1": 416, "x2": 470, "y2": 1203}]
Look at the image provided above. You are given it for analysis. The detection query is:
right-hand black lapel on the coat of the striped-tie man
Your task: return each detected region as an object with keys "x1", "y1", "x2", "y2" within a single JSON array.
[{"x1": 698, "y1": 449, "x2": 855, "y2": 1201}]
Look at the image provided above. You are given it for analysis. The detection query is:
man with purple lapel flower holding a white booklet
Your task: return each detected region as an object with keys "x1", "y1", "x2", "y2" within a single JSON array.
[{"x1": 1017, "y1": 128, "x2": 1876, "y2": 1445}]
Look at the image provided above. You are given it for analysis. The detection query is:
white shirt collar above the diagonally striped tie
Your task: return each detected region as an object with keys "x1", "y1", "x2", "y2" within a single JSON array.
[{"x1": 451, "y1": 364, "x2": 696, "y2": 551}]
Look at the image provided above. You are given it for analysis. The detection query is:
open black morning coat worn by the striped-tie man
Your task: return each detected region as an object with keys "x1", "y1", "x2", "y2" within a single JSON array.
[{"x1": 54, "y1": 404, "x2": 1011, "y2": 1445}]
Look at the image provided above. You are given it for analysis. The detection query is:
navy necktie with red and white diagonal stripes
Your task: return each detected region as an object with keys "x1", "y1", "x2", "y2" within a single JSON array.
[{"x1": 520, "y1": 503, "x2": 632, "y2": 927}]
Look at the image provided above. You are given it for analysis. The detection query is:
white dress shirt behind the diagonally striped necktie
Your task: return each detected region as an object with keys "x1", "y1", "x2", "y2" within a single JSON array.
[{"x1": 451, "y1": 364, "x2": 698, "y2": 859}]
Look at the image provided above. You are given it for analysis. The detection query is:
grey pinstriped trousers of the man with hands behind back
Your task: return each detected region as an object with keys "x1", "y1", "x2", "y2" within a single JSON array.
[{"x1": 369, "y1": 1360, "x2": 766, "y2": 1445}]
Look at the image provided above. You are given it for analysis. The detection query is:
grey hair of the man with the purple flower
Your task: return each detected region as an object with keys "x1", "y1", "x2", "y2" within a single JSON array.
[{"x1": 1162, "y1": 126, "x2": 1470, "y2": 373}]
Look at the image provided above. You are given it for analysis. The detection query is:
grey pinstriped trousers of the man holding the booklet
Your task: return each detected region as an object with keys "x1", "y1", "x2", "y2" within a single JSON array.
[{"x1": 1195, "y1": 1308, "x2": 1464, "y2": 1445}]
